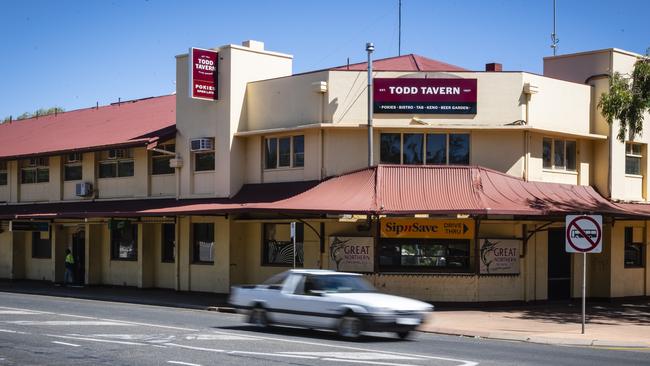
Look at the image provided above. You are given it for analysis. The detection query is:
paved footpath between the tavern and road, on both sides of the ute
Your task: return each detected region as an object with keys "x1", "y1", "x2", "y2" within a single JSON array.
[{"x1": 0, "y1": 280, "x2": 650, "y2": 350}]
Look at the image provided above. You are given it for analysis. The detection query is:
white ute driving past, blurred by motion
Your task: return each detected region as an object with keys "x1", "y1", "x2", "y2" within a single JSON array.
[{"x1": 228, "y1": 269, "x2": 433, "y2": 339}]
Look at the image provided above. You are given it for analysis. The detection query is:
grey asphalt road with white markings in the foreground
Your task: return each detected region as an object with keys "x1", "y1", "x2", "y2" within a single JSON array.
[{"x1": 0, "y1": 293, "x2": 650, "y2": 366}]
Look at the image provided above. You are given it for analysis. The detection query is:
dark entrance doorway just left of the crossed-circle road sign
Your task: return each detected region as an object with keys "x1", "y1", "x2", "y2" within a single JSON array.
[{"x1": 548, "y1": 229, "x2": 571, "y2": 300}]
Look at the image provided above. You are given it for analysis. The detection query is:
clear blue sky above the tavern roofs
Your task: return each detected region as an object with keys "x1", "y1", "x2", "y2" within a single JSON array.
[{"x1": 0, "y1": 0, "x2": 650, "y2": 119}]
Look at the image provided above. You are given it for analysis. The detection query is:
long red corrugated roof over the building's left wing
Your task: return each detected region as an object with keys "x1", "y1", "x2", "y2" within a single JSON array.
[{"x1": 0, "y1": 95, "x2": 176, "y2": 158}]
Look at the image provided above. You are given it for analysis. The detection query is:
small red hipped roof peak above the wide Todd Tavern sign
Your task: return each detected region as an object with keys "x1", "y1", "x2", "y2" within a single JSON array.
[{"x1": 330, "y1": 54, "x2": 468, "y2": 72}]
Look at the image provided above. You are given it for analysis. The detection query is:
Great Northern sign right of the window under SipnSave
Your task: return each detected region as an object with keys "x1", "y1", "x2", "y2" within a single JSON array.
[{"x1": 480, "y1": 239, "x2": 521, "y2": 274}]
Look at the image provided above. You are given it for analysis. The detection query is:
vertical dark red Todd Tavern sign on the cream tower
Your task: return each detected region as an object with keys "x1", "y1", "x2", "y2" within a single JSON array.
[{"x1": 190, "y1": 47, "x2": 219, "y2": 100}]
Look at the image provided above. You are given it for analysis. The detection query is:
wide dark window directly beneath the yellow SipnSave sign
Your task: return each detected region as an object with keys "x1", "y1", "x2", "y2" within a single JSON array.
[{"x1": 379, "y1": 238, "x2": 470, "y2": 272}]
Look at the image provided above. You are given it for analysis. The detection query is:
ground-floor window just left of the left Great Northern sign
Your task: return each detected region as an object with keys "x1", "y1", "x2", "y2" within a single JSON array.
[{"x1": 262, "y1": 223, "x2": 305, "y2": 267}]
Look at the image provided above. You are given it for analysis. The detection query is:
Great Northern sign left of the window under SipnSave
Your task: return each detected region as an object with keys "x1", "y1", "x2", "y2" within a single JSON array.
[{"x1": 329, "y1": 236, "x2": 375, "y2": 272}]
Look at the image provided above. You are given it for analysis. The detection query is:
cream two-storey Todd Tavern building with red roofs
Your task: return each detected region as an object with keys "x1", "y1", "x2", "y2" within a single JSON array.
[{"x1": 0, "y1": 41, "x2": 650, "y2": 302}]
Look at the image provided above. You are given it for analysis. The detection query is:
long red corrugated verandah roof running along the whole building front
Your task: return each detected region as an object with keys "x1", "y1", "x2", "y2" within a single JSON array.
[{"x1": 0, "y1": 165, "x2": 636, "y2": 219}]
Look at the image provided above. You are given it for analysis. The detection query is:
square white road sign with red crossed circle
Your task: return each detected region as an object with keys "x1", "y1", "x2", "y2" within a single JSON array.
[{"x1": 566, "y1": 215, "x2": 603, "y2": 253}]
